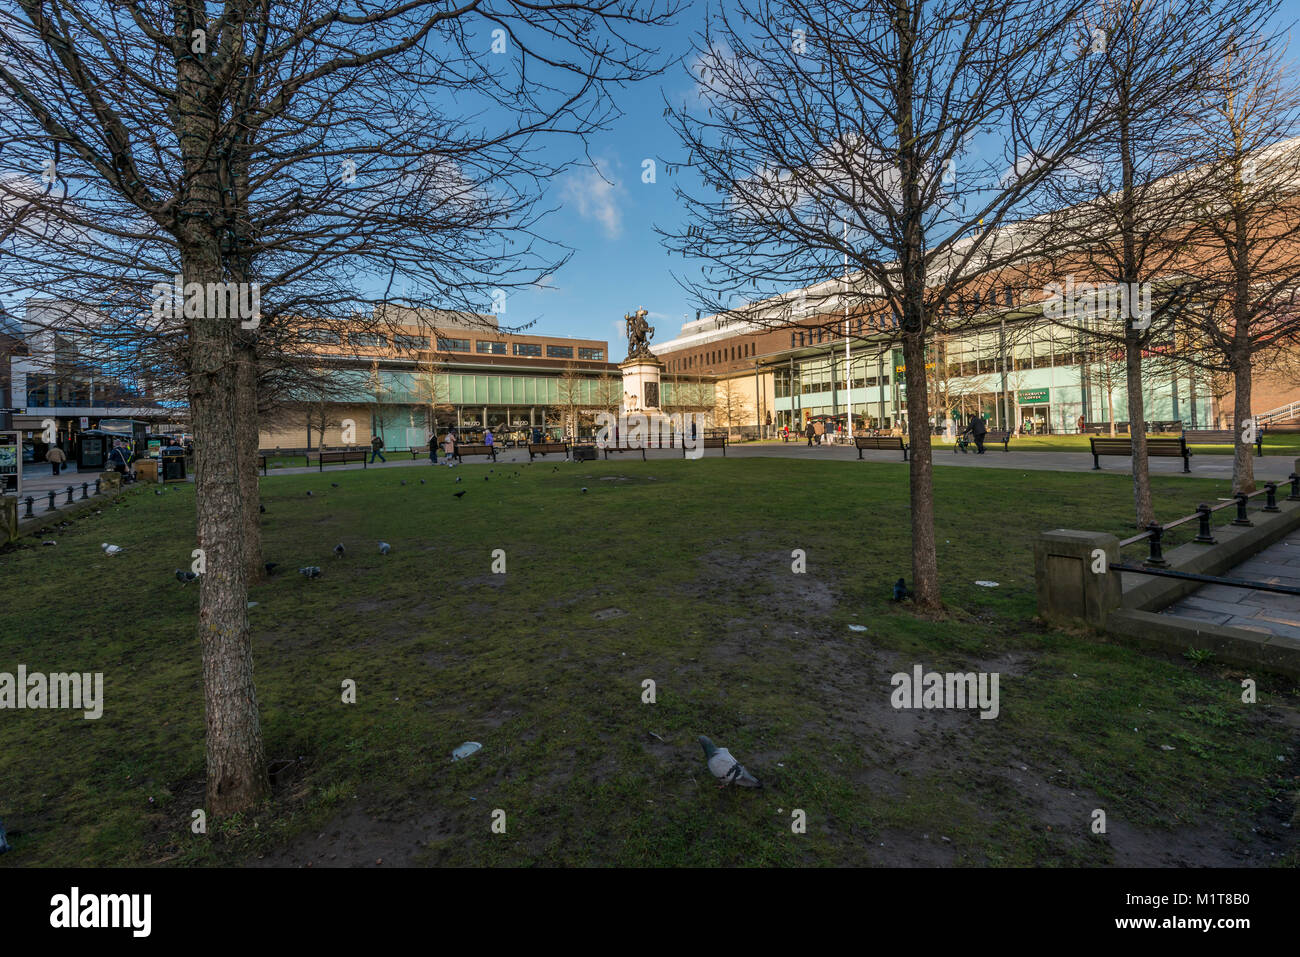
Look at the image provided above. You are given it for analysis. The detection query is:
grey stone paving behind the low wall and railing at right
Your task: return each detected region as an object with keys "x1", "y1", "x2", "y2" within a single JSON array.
[{"x1": 1161, "y1": 534, "x2": 1300, "y2": 645}]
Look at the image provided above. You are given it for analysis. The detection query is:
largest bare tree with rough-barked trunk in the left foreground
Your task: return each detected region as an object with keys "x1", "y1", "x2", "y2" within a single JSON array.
[{"x1": 0, "y1": 0, "x2": 672, "y2": 814}]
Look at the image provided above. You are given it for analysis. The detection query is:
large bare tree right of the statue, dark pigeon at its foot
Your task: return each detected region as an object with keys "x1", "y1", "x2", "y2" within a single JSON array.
[{"x1": 670, "y1": 0, "x2": 1105, "y2": 610}]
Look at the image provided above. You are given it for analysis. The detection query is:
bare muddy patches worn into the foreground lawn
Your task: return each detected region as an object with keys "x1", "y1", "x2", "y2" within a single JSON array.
[{"x1": 239, "y1": 553, "x2": 1300, "y2": 867}]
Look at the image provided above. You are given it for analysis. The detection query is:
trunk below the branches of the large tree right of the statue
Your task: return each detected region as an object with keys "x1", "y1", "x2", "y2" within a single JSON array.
[{"x1": 902, "y1": 328, "x2": 940, "y2": 609}]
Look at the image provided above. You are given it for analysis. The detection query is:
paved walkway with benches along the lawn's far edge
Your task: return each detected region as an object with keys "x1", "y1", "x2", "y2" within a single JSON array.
[{"x1": 256, "y1": 442, "x2": 1295, "y2": 485}]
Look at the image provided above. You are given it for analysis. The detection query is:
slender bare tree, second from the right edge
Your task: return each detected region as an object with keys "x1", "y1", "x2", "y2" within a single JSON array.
[{"x1": 1024, "y1": 0, "x2": 1268, "y2": 527}]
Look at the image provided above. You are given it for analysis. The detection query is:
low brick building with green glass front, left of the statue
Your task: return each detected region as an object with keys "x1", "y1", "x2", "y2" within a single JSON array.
[{"x1": 253, "y1": 307, "x2": 712, "y2": 449}]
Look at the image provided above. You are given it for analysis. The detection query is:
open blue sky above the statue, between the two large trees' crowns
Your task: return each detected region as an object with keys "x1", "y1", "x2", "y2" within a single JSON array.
[{"x1": 501, "y1": 0, "x2": 1300, "y2": 351}]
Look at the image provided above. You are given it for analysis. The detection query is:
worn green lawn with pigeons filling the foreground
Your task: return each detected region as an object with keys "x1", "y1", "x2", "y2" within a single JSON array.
[{"x1": 0, "y1": 458, "x2": 1300, "y2": 867}]
